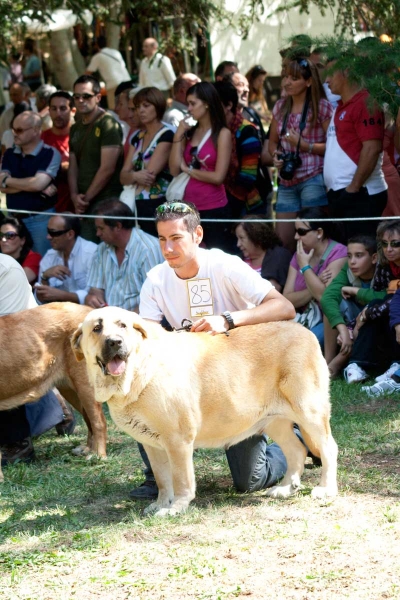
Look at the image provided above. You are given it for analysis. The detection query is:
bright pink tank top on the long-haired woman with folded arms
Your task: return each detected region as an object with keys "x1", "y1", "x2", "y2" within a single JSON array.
[{"x1": 183, "y1": 137, "x2": 228, "y2": 211}]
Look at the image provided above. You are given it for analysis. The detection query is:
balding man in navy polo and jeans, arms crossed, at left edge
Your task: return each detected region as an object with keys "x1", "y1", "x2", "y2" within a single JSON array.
[{"x1": 0, "y1": 111, "x2": 61, "y2": 256}]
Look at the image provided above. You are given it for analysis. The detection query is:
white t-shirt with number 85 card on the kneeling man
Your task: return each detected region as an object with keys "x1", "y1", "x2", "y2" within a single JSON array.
[{"x1": 139, "y1": 248, "x2": 273, "y2": 328}]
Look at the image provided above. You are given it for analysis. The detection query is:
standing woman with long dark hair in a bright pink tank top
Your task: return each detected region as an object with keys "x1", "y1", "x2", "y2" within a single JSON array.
[{"x1": 169, "y1": 82, "x2": 232, "y2": 251}]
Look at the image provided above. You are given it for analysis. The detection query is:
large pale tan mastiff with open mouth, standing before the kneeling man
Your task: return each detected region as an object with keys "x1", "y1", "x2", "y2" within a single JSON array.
[{"x1": 72, "y1": 307, "x2": 337, "y2": 516}]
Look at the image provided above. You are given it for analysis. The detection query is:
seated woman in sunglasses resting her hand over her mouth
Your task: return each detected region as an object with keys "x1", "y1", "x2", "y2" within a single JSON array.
[{"x1": 283, "y1": 208, "x2": 347, "y2": 346}]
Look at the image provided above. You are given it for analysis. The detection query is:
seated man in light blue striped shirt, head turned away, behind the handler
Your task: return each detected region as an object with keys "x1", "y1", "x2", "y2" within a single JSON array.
[{"x1": 85, "y1": 199, "x2": 163, "y2": 311}]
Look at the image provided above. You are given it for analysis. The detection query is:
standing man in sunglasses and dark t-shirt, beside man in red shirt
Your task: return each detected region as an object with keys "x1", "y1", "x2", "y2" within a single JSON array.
[{"x1": 68, "y1": 75, "x2": 123, "y2": 242}]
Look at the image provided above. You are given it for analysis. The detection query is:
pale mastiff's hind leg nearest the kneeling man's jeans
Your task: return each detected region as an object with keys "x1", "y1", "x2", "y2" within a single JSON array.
[{"x1": 266, "y1": 417, "x2": 307, "y2": 498}]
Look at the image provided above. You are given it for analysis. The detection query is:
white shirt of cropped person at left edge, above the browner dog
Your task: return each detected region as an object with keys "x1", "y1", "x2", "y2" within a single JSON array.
[{"x1": 0, "y1": 254, "x2": 37, "y2": 316}]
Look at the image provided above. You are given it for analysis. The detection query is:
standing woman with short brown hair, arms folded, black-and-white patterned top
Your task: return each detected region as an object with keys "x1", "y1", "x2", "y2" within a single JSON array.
[{"x1": 120, "y1": 87, "x2": 174, "y2": 235}]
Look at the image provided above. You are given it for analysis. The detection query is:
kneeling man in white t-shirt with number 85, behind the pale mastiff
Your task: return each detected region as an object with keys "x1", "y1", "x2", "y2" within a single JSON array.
[{"x1": 130, "y1": 202, "x2": 295, "y2": 499}]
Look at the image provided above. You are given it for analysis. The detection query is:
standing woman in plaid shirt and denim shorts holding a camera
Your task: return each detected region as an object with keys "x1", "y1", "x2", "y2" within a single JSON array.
[{"x1": 269, "y1": 58, "x2": 333, "y2": 248}]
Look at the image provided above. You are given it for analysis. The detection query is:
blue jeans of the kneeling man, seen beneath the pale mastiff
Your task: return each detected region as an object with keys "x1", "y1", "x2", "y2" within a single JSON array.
[{"x1": 138, "y1": 435, "x2": 287, "y2": 492}]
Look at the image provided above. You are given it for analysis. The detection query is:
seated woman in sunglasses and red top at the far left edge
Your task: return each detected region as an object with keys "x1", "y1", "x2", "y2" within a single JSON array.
[{"x1": 0, "y1": 217, "x2": 42, "y2": 285}]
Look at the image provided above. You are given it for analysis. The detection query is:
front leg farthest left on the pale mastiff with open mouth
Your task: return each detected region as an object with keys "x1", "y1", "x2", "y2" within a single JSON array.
[{"x1": 144, "y1": 445, "x2": 174, "y2": 517}]
